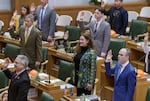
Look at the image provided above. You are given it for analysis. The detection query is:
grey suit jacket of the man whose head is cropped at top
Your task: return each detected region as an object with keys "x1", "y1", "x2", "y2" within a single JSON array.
[{"x1": 36, "y1": 5, "x2": 56, "y2": 41}]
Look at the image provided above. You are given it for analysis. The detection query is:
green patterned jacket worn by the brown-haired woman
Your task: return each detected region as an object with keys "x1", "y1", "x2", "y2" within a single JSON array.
[{"x1": 74, "y1": 49, "x2": 96, "y2": 88}]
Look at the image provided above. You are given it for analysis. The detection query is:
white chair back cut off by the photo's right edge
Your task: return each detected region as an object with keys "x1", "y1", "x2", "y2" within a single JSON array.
[{"x1": 140, "y1": 7, "x2": 150, "y2": 18}]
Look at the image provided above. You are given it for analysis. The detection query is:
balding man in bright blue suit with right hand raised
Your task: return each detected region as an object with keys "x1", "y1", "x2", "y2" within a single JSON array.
[{"x1": 105, "y1": 48, "x2": 136, "y2": 101}]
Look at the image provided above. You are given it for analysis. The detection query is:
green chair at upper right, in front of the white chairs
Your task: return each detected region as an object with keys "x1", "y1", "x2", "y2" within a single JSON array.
[{"x1": 129, "y1": 20, "x2": 148, "y2": 40}]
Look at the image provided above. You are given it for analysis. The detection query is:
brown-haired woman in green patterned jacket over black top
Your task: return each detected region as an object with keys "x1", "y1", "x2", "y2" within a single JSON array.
[{"x1": 74, "y1": 32, "x2": 96, "y2": 96}]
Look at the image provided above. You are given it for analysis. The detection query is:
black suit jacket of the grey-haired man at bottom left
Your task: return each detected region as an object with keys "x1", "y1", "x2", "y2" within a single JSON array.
[{"x1": 3, "y1": 69, "x2": 30, "y2": 101}]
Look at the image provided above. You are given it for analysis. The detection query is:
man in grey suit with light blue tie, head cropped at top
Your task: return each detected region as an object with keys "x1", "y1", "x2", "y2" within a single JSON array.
[{"x1": 36, "y1": 0, "x2": 56, "y2": 41}]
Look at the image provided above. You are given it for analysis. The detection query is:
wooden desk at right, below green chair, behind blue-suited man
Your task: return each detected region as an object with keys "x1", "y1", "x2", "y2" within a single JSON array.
[{"x1": 126, "y1": 41, "x2": 145, "y2": 70}]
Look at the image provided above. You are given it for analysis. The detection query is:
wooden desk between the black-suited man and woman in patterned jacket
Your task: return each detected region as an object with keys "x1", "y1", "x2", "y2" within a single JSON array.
[{"x1": 31, "y1": 76, "x2": 76, "y2": 101}]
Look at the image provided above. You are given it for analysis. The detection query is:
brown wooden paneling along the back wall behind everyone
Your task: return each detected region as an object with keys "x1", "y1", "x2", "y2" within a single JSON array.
[{"x1": 0, "y1": 0, "x2": 150, "y2": 31}]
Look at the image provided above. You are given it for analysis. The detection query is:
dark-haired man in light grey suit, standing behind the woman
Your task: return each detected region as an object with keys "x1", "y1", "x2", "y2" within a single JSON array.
[{"x1": 78, "y1": 8, "x2": 110, "y2": 57}]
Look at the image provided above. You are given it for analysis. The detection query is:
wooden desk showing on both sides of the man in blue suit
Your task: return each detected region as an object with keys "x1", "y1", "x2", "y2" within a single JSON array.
[{"x1": 100, "y1": 65, "x2": 150, "y2": 101}]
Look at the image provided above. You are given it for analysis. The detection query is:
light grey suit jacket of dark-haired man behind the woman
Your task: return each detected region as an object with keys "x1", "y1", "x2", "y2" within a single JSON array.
[{"x1": 78, "y1": 20, "x2": 110, "y2": 56}]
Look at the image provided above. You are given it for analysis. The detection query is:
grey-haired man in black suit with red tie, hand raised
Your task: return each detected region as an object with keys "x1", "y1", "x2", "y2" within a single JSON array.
[{"x1": 3, "y1": 55, "x2": 30, "y2": 101}]
